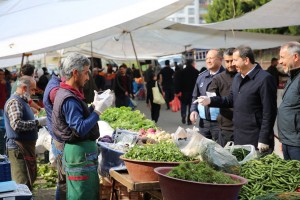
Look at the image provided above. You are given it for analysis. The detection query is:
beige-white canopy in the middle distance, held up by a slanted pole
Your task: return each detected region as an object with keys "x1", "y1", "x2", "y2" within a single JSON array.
[{"x1": 64, "y1": 21, "x2": 300, "y2": 59}]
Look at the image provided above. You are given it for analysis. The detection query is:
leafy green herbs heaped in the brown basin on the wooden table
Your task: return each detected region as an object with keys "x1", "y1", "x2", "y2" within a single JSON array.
[{"x1": 124, "y1": 142, "x2": 194, "y2": 162}]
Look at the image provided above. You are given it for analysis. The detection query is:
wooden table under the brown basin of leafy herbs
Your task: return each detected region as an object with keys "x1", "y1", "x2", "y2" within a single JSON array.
[{"x1": 109, "y1": 169, "x2": 163, "y2": 200}]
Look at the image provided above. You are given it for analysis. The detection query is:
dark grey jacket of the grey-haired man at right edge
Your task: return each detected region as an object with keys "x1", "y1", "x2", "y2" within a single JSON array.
[{"x1": 277, "y1": 69, "x2": 300, "y2": 147}]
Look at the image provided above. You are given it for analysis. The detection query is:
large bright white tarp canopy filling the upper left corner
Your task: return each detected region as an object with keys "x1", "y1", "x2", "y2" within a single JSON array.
[{"x1": 0, "y1": 0, "x2": 192, "y2": 58}]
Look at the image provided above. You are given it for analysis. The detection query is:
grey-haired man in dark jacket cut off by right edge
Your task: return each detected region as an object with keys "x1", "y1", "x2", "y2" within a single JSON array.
[{"x1": 277, "y1": 42, "x2": 300, "y2": 161}]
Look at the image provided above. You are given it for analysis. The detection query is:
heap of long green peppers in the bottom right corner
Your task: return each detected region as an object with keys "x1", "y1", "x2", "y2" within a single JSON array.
[{"x1": 239, "y1": 153, "x2": 300, "y2": 200}]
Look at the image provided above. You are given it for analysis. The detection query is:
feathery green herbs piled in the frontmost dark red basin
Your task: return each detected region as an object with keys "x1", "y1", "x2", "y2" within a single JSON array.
[{"x1": 167, "y1": 162, "x2": 239, "y2": 184}]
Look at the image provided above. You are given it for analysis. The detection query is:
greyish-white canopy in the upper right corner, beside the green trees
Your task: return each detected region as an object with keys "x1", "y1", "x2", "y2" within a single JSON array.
[{"x1": 200, "y1": 0, "x2": 300, "y2": 30}]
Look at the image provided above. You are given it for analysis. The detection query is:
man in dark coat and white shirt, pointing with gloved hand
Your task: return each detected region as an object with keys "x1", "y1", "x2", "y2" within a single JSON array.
[{"x1": 199, "y1": 46, "x2": 277, "y2": 152}]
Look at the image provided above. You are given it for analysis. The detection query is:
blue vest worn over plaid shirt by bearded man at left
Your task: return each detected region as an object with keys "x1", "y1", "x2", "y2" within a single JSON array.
[{"x1": 4, "y1": 95, "x2": 38, "y2": 148}]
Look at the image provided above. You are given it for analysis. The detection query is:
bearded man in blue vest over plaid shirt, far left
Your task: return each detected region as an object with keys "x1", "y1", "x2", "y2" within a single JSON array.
[{"x1": 4, "y1": 76, "x2": 46, "y2": 190}]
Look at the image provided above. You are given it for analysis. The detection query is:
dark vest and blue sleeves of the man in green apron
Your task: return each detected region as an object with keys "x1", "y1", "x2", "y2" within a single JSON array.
[{"x1": 52, "y1": 88, "x2": 100, "y2": 143}]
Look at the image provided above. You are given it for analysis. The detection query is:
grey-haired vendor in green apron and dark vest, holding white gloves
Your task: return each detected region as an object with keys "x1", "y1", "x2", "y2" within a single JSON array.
[{"x1": 52, "y1": 53, "x2": 107, "y2": 200}]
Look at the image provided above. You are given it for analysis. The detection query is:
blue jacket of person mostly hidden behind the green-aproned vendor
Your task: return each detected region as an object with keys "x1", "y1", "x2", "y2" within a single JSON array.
[{"x1": 43, "y1": 75, "x2": 61, "y2": 140}]
